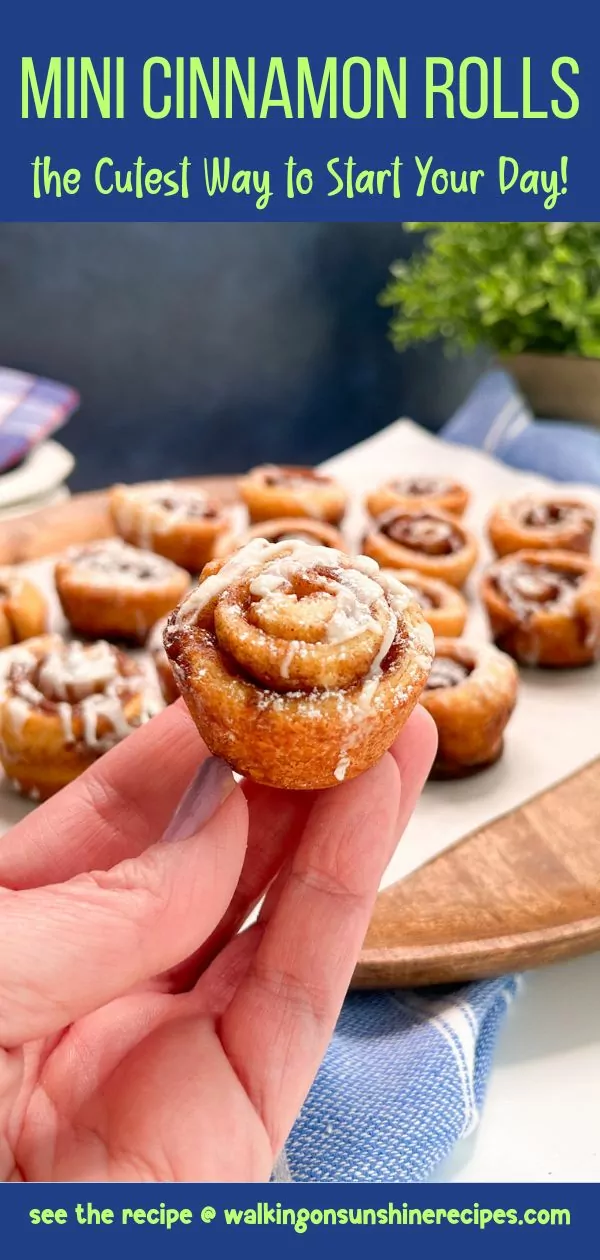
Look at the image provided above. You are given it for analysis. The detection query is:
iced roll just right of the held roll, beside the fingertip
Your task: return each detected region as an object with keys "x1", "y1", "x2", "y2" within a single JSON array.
[{"x1": 421, "y1": 639, "x2": 518, "y2": 779}]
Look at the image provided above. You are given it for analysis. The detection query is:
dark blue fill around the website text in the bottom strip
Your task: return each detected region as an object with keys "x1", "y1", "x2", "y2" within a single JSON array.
[{"x1": 0, "y1": 1184, "x2": 584, "y2": 1260}]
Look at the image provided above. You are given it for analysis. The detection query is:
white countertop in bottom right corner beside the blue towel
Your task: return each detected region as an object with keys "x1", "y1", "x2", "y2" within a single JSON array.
[{"x1": 432, "y1": 954, "x2": 600, "y2": 1182}]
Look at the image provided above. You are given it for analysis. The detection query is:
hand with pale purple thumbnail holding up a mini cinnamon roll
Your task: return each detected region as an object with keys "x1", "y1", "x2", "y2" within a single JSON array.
[{"x1": 0, "y1": 703, "x2": 436, "y2": 1182}]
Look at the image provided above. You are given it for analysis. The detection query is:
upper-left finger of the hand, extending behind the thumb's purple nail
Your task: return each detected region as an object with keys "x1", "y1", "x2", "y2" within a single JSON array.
[{"x1": 0, "y1": 701, "x2": 208, "y2": 890}]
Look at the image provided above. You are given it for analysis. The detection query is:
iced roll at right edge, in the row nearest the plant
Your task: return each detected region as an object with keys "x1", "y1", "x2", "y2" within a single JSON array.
[{"x1": 488, "y1": 498, "x2": 595, "y2": 556}]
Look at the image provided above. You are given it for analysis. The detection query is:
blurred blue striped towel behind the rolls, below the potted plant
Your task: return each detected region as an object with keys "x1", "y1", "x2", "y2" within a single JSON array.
[{"x1": 440, "y1": 368, "x2": 600, "y2": 485}]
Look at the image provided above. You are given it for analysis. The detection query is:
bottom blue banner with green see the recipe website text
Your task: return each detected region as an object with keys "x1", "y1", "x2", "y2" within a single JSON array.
[{"x1": 0, "y1": 1184, "x2": 589, "y2": 1260}]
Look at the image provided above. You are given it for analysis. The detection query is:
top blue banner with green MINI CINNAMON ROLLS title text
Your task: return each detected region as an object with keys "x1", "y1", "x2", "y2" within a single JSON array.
[{"x1": 0, "y1": 0, "x2": 600, "y2": 222}]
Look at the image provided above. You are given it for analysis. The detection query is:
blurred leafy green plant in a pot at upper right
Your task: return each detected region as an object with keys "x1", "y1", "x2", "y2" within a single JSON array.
[{"x1": 381, "y1": 223, "x2": 600, "y2": 425}]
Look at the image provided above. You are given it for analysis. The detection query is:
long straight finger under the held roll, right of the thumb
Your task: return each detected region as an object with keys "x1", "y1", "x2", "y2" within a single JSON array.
[{"x1": 219, "y1": 753, "x2": 400, "y2": 1152}]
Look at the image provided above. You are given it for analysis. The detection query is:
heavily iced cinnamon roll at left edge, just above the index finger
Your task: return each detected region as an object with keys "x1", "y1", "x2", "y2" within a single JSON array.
[{"x1": 0, "y1": 635, "x2": 160, "y2": 800}]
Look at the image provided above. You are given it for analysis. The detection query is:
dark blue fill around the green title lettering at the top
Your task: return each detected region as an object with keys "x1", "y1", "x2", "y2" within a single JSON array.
[{"x1": 0, "y1": 0, "x2": 600, "y2": 221}]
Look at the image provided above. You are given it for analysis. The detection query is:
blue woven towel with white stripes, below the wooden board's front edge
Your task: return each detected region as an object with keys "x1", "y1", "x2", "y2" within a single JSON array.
[{"x1": 274, "y1": 977, "x2": 518, "y2": 1182}]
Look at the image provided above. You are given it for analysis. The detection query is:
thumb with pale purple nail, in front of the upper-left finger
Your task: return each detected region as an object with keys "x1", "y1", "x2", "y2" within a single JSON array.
[{"x1": 0, "y1": 766, "x2": 248, "y2": 1047}]
